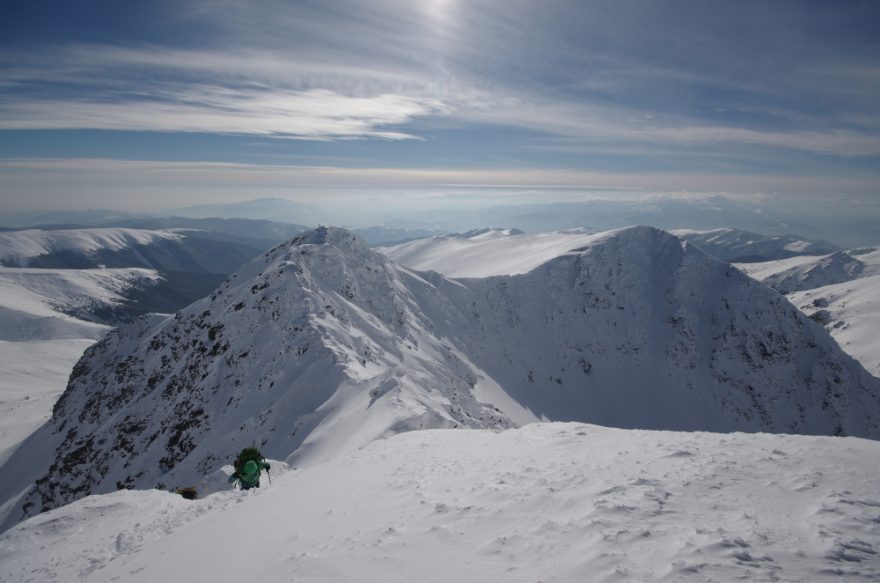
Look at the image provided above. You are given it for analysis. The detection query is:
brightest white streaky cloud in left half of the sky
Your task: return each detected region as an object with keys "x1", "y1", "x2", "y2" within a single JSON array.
[{"x1": 0, "y1": 85, "x2": 443, "y2": 140}]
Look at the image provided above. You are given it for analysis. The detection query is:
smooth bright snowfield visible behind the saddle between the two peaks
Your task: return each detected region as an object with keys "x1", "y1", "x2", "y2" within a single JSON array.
[{"x1": 379, "y1": 229, "x2": 593, "y2": 277}]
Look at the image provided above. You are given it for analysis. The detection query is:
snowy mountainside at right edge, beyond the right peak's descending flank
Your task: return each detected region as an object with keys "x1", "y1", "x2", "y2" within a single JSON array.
[{"x1": 737, "y1": 248, "x2": 880, "y2": 377}]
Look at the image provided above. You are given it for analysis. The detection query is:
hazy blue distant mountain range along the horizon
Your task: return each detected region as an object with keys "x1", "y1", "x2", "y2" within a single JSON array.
[{"x1": 0, "y1": 196, "x2": 880, "y2": 247}]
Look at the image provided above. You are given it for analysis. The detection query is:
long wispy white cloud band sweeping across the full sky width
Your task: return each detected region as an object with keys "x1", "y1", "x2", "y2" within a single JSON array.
[{"x1": 0, "y1": 45, "x2": 880, "y2": 156}]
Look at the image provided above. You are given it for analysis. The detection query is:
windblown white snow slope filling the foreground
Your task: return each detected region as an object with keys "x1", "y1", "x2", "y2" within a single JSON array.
[{"x1": 0, "y1": 423, "x2": 880, "y2": 583}]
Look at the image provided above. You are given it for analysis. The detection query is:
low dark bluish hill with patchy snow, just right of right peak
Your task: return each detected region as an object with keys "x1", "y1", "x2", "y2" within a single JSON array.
[{"x1": 671, "y1": 228, "x2": 839, "y2": 262}]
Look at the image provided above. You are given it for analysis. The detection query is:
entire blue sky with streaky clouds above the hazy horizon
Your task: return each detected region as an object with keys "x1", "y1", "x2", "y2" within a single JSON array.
[{"x1": 0, "y1": 0, "x2": 880, "y2": 220}]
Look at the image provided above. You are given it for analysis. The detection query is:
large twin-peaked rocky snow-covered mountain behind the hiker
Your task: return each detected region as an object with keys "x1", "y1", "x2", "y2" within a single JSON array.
[{"x1": 0, "y1": 227, "x2": 880, "y2": 524}]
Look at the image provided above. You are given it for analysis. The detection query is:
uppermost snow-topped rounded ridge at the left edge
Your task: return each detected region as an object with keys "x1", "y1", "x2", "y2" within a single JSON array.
[{"x1": 0, "y1": 228, "x2": 182, "y2": 267}]
